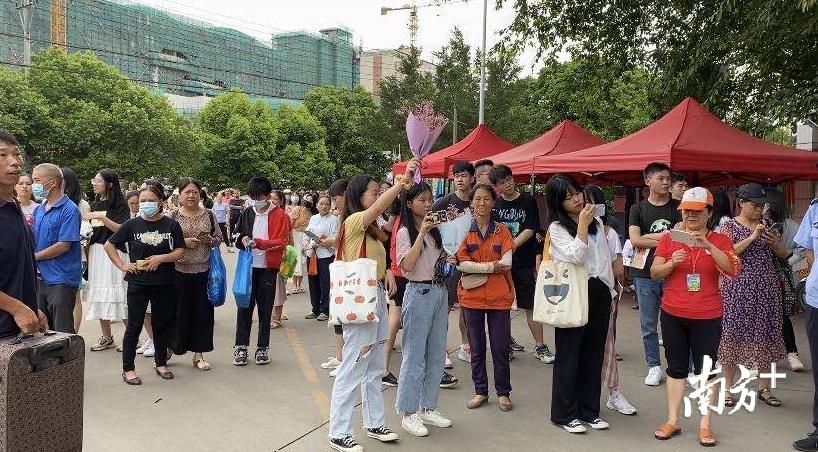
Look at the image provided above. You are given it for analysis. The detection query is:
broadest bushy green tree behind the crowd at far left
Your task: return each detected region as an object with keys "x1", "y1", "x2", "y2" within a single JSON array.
[{"x1": 23, "y1": 48, "x2": 203, "y2": 184}]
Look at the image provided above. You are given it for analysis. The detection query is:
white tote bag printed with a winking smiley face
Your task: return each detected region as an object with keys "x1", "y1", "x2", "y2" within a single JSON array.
[{"x1": 533, "y1": 233, "x2": 588, "y2": 328}]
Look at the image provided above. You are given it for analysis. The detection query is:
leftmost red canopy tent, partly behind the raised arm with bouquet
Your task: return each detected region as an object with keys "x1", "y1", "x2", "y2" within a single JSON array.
[{"x1": 392, "y1": 124, "x2": 514, "y2": 178}]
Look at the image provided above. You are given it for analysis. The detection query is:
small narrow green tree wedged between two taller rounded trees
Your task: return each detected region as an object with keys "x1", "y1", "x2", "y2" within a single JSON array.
[{"x1": 275, "y1": 106, "x2": 335, "y2": 190}]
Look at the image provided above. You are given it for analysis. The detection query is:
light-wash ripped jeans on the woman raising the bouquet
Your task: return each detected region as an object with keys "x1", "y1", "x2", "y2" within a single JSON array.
[{"x1": 329, "y1": 285, "x2": 389, "y2": 438}]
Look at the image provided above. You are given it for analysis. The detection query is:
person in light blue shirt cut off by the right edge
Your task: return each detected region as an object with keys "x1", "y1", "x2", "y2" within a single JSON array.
[{"x1": 793, "y1": 199, "x2": 818, "y2": 451}]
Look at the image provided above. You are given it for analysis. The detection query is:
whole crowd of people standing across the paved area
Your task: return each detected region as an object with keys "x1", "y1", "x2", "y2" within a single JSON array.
[{"x1": 0, "y1": 125, "x2": 818, "y2": 452}]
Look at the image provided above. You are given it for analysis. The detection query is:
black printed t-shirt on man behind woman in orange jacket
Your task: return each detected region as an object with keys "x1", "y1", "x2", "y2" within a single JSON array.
[{"x1": 492, "y1": 193, "x2": 540, "y2": 268}]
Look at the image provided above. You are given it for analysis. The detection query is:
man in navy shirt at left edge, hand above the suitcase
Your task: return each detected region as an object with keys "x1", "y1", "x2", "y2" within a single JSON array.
[{"x1": 0, "y1": 130, "x2": 48, "y2": 337}]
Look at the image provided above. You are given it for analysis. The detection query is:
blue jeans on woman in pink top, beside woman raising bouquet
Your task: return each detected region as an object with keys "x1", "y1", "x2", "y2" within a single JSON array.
[{"x1": 395, "y1": 281, "x2": 449, "y2": 413}]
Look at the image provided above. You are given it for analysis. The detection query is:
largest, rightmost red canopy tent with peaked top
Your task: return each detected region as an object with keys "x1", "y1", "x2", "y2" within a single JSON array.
[{"x1": 534, "y1": 97, "x2": 818, "y2": 185}]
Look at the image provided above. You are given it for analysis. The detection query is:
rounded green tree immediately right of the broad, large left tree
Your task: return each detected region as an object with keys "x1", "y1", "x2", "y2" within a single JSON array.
[{"x1": 198, "y1": 91, "x2": 283, "y2": 188}]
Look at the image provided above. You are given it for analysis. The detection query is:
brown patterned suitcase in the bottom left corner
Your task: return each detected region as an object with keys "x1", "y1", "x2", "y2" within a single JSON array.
[{"x1": 0, "y1": 331, "x2": 85, "y2": 452}]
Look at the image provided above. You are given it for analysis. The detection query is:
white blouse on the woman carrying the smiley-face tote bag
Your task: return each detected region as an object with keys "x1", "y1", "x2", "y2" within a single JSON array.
[{"x1": 548, "y1": 220, "x2": 616, "y2": 296}]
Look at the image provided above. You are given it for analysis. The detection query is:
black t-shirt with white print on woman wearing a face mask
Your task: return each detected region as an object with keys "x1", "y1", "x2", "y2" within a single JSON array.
[{"x1": 108, "y1": 215, "x2": 185, "y2": 286}]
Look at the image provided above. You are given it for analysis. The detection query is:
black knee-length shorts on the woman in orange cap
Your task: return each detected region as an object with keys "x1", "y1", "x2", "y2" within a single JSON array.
[{"x1": 659, "y1": 311, "x2": 721, "y2": 380}]
